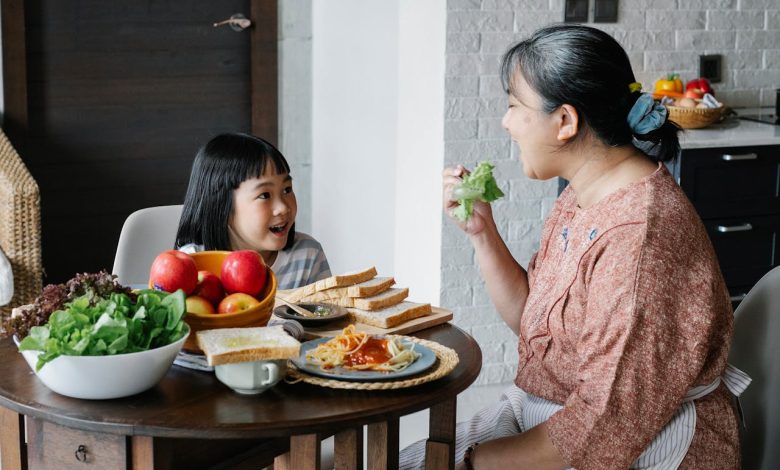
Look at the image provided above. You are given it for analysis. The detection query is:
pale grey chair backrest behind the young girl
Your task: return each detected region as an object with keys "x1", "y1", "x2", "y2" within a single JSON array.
[{"x1": 112, "y1": 205, "x2": 182, "y2": 285}]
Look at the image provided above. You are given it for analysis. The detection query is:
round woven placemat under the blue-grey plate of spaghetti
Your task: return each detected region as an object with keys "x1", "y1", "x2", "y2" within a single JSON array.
[{"x1": 285, "y1": 335, "x2": 458, "y2": 390}]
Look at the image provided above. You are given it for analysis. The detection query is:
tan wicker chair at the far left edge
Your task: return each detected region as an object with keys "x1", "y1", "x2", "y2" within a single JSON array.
[{"x1": 0, "y1": 130, "x2": 43, "y2": 319}]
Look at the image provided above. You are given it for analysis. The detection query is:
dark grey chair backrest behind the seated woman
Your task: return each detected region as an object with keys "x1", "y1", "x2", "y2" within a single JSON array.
[{"x1": 729, "y1": 266, "x2": 780, "y2": 470}]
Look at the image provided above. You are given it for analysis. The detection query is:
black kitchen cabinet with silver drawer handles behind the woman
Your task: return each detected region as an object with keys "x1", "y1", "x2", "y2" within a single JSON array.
[{"x1": 670, "y1": 145, "x2": 780, "y2": 302}]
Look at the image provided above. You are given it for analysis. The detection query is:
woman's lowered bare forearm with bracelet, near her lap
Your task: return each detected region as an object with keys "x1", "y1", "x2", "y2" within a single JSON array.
[{"x1": 455, "y1": 423, "x2": 568, "y2": 470}]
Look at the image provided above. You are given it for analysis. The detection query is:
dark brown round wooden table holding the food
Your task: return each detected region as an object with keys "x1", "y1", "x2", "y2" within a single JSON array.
[{"x1": 0, "y1": 324, "x2": 482, "y2": 470}]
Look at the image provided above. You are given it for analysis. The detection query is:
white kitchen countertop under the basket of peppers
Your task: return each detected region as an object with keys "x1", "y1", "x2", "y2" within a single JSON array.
[{"x1": 680, "y1": 108, "x2": 780, "y2": 149}]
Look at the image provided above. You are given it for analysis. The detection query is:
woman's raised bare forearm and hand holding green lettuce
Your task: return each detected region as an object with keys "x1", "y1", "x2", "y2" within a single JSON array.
[{"x1": 443, "y1": 165, "x2": 528, "y2": 334}]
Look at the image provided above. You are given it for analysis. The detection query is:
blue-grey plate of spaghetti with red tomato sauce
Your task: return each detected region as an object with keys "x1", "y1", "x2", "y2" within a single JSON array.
[{"x1": 293, "y1": 325, "x2": 436, "y2": 381}]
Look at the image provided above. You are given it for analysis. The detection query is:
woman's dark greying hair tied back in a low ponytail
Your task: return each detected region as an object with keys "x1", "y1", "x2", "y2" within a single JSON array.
[{"x1": 501, "y1": 24, "x2": 680, "y2": 161}]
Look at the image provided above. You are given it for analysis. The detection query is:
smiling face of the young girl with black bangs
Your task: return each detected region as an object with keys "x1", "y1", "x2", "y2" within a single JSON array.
[{"x1": 228, "y1": 164, "x2": 298, "y2": 262}]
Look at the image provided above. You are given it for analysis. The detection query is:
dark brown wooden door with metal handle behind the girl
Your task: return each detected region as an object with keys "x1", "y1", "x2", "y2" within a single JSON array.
[{"x1": 2, "y1": 0, "x2": 277, "y2": 282}]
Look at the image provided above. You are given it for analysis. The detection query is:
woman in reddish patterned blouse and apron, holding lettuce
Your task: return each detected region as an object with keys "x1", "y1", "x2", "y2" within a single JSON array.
[{"x1": 401, "y1": 25, "x2": 747, "y2": 470}]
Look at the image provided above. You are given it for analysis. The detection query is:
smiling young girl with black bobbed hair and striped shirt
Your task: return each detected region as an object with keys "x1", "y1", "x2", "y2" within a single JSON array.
[{"x1": 176, "y1": 133, "x2": 330, "y2": 289}]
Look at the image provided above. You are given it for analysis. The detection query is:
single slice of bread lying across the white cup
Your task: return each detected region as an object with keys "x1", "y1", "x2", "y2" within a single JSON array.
[{"x1": 197, "y1": 325, "x2": 301, "y2": 366}]
